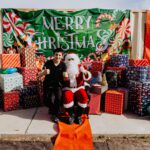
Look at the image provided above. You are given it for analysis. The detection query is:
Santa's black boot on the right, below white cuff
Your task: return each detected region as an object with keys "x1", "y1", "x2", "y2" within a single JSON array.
[{"x1": 75, "y1": 106, "x2": 85, "y2": 124}]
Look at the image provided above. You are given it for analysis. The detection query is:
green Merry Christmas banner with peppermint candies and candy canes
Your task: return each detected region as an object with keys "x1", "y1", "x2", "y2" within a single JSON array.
[{"x1": 2, "y1": 9, "x2": 131, "y2": 60}]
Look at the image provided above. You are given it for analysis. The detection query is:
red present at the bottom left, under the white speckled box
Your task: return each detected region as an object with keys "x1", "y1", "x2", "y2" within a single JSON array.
[{"x1": 0, "y1": 90, "x2": 19, "y2": 111}]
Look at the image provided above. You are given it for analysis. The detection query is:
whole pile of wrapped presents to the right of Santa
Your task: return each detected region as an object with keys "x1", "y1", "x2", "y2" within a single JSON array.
[{"x1": 85, "y1": 54, "x2": 150, "y2": 116}]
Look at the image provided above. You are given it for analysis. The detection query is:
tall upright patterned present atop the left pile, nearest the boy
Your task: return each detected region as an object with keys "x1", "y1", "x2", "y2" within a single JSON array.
[{"x1": 19, "y1": 47, "x2": 36, "y2": 68}]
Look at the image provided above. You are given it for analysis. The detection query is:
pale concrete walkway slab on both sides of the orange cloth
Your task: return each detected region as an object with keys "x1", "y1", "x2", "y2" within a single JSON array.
[{"x1": 0, "y1": 107, "x2": 150, "y2": 136}]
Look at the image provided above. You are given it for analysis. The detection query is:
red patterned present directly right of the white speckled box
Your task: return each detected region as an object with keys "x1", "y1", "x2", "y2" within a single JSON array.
[{"x1": 19, "y1": 67, "x2": 38, "y2": 86}]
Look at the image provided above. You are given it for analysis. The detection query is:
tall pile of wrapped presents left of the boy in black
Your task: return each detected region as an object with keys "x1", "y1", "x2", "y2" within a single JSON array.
[{"x1": 0, "y1": 48, "x2": 41, "y2": 111}]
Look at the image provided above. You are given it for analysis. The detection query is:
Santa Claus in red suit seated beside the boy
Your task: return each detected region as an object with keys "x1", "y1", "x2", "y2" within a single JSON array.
[{"x1": 63, "y1": 53, "x2": 91, "y2": 124}]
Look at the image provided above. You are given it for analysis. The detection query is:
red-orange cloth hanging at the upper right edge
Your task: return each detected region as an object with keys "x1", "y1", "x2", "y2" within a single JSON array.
[{"x1": 144, "y1": 11, "x2": 150, "y2": 64}]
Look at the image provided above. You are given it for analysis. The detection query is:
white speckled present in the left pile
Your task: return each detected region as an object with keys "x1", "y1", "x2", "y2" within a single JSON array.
[{"x1": 0, "y1": 72, "x2": 23, "y2": 92}]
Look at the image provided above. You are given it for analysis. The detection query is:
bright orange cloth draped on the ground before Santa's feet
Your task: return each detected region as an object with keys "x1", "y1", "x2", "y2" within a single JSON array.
[{"x1": 54, "y1": 119, "x2": 93, "y2": 150}]
